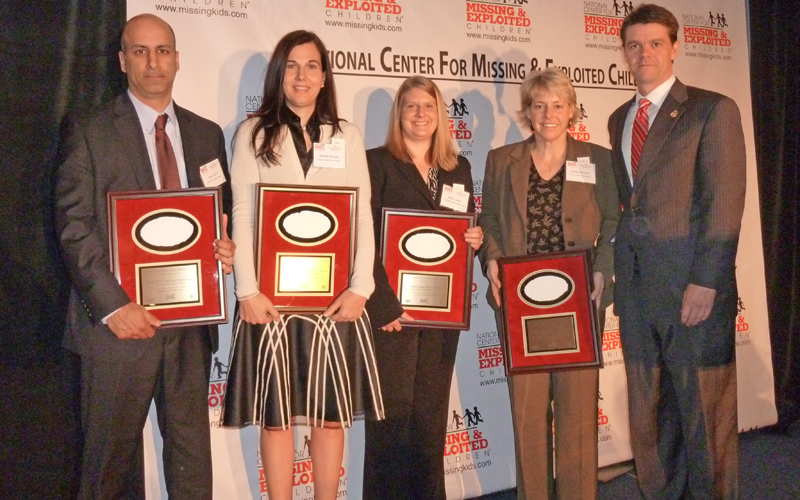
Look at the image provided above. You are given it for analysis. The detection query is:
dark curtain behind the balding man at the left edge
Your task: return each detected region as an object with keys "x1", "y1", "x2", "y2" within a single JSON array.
[{"x1": 0, "y1": 0, "x2": 125, "y2": 499}]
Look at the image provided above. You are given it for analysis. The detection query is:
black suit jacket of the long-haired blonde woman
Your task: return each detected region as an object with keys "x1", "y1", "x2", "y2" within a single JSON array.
[{"x1": 366, "y1": 147, "x2": 475, "y2": 328}]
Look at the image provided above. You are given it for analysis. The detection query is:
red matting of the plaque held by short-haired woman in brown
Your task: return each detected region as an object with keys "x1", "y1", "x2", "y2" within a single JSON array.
[{"x1": 498, "y1": 250, "x2": 602, "y2": 375}]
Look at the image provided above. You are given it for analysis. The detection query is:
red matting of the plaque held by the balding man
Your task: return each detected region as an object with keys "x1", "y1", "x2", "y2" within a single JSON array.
[{"x1": 108, "y1": 188, "x2": 228, "y2": 326}]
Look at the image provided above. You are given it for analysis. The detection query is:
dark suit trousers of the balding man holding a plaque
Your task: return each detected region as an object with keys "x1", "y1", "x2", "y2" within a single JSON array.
[{"x1": 79, "y1": 327, "x2": 212, "y2": 500}]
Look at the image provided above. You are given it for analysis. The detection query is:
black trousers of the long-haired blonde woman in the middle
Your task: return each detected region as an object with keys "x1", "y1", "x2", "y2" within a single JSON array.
[{"x1": 363, "y1": 327, "x2": 460, "y2": 500}]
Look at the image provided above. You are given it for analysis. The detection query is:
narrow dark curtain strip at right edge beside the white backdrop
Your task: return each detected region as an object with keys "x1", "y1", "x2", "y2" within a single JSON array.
[{"x1": 749, "y1": 0, "x2": 800, "y2": 430}]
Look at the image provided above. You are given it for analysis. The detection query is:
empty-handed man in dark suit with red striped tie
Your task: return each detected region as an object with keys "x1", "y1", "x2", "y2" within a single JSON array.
[{"x1": 608, "y1": 5, "x2": 746, "y2": 499}]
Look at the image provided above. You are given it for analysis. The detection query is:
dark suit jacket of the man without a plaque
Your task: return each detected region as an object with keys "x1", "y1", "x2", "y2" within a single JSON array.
[{"x1": 608, "y1": 80, "x2": 746, "y2": 335}]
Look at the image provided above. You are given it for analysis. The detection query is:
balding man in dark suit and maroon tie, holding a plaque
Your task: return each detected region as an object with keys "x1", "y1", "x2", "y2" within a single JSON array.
[{"x1": 55, "y1": 14, "x2": 235, "y2": 499}]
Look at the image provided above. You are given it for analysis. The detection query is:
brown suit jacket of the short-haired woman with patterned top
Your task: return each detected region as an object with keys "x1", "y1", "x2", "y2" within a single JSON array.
[{"x1": 479, "y1": 135, "x2": 619, "y2": 309}]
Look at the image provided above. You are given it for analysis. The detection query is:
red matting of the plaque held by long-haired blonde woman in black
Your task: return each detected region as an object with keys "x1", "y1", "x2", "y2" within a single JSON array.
[{"x1": 380, "y1": 208, "x2": 476, "y2": 330}]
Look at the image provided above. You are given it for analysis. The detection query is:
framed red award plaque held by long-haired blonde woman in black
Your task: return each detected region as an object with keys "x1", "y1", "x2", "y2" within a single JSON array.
[{"x1": 380, "y1": 208, "x2": 476, "y2": 330}]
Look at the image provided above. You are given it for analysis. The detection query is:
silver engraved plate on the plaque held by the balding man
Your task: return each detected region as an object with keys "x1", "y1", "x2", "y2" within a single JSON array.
[{"x1": 136, "y1": 261, "x2": 203, "y2": 309}]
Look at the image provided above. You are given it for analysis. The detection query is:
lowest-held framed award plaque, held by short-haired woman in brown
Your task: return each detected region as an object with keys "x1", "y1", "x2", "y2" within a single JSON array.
[{"x1": 498, "y1": 250, "x2": 603, "y2": 375}]
